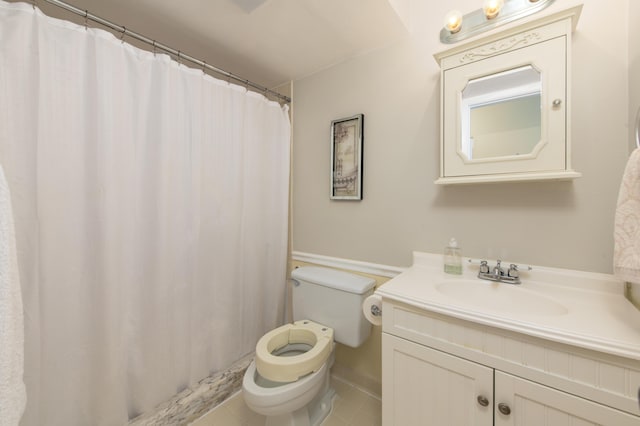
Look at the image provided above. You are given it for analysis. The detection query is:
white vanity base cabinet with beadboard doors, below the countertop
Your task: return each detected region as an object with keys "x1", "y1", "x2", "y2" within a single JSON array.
[{"x1": 382, "y1": 299, "x2": 640, "y2": 426}]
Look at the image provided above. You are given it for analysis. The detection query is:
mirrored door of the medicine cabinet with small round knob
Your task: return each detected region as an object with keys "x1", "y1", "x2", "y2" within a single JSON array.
[{"x1": 444, "y1": 34, "x2": 566, "y2": 176}]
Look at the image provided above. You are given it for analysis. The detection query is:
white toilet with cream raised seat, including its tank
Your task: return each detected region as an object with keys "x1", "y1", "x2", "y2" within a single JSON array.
[{"x1": 242, "y1": 266, "x2": 375, "y2": 426}]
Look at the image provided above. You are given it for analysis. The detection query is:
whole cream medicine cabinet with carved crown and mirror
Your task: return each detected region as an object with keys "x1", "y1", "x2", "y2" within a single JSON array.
[{"x1": 435, "y1": 5, "x2": 582, "y2": 185}]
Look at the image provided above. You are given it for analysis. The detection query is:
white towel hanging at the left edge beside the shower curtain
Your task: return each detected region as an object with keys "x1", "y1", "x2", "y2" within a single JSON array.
[{"x1": 0, "y1": 166, "x2": 27, "y2": 426}]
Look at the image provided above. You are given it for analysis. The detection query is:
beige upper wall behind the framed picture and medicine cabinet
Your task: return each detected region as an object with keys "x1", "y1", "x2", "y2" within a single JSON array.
[{"x1": 293, "y1": 0, "x2": 639, "y2": 273}]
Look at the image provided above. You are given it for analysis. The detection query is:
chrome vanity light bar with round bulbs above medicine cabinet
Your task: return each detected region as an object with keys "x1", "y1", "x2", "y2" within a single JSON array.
[{"x1": 440, "y1": 0, "x2": 555, "y2": 44}]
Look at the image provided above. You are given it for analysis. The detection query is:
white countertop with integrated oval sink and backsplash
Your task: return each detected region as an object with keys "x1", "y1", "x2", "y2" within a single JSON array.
[{"x1": 376, "y1": 252, "x2": 640, "y2": 360}]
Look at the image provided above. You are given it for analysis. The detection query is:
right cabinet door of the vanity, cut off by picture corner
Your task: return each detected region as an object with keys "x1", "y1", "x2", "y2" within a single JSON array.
[{"x1": 495, "y1": 371, "x2": 640, "y2": 426}]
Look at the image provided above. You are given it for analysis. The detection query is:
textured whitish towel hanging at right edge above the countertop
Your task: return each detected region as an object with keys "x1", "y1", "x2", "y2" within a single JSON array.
[{"x1": 613, "y1": 148, "x2": 640, "y2": 283}]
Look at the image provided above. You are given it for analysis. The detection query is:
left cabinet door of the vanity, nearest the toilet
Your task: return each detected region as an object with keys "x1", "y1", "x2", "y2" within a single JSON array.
[{"x1": 382, "y1": 333, "x2": 493, "y2": 426}]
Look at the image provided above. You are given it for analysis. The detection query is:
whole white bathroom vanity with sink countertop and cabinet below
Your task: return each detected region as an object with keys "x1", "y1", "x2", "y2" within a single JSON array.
[{"x1": 376, "y1": 253, "x2": 640, "y2": 426}]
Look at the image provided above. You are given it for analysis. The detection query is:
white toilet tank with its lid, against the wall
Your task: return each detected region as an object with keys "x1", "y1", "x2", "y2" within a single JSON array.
[{"x1": 291, "y1": 266, "x2": 375, "y2": 348}]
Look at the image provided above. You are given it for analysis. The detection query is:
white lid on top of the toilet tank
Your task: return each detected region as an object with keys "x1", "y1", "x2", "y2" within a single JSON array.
[{"x1": 291, "y1": 266, "x2": 376, "y2": 294}]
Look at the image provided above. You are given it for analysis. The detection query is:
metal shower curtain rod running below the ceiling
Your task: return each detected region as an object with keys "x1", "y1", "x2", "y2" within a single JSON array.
[{"x1": 32, "y1": 0, "x2": 291, "y2": 103}]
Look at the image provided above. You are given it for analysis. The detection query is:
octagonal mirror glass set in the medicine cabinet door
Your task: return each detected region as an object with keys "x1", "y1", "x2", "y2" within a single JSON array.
[{"x1": 460, "y1": 65, "x2": 542, "y2": 162}]
